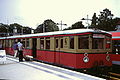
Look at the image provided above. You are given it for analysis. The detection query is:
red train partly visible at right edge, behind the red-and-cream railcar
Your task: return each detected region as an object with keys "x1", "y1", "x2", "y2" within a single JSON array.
[{"x1": 111, "y1": 31, "x2": 120, "y2": 65}]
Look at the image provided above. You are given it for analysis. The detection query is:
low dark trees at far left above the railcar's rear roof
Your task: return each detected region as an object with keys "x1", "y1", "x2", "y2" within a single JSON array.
[{"x1": 0, "y1": 23, "x2": 31, "y2": 36}]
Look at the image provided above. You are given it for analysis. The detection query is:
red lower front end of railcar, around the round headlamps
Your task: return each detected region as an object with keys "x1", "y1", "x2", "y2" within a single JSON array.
[{"x1": 76, "y1": 54, "x2": 112, "y2": 68}]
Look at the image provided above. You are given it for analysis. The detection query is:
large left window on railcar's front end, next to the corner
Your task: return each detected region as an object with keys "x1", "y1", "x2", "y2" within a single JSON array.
[{"x1": 78, "y1": 36, "x2": 89, "y2": 49}]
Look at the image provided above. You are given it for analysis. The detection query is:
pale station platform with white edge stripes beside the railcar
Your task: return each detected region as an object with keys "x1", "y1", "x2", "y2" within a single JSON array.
[{"x1": 0, "y1": 55, "x2": 105, "y2": 80}]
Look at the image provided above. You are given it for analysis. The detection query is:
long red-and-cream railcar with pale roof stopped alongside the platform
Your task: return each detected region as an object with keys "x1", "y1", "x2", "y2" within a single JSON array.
[{"x1": 0, "y1": 29, "x2": 112, "y2": 69}]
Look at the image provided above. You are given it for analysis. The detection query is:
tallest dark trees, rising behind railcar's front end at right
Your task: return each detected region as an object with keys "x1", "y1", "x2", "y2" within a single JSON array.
[{"x1": 91, "y1": 8, "x2": 119, "y2": 31}]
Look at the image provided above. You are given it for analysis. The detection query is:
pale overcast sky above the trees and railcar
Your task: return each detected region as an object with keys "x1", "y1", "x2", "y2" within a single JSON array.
[{"x1": 0, "y1": 0, "x2": 120, "y2": 29}]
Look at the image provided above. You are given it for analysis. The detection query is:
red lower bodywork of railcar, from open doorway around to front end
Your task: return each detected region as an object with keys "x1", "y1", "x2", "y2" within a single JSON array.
[{"x1": 36, "y1": 50, "x2": 112, "y2": 69}]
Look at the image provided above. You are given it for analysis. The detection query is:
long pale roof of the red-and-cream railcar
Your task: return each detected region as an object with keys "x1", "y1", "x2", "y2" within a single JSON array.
[{"x1": 0, "y1": 29, "x2": 110, "y2": 39}]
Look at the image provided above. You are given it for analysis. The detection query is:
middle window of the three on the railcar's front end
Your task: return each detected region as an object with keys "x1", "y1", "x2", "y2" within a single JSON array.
[{"x1": 92, "y1": 38, "x2": 104, "y2": 49}]
